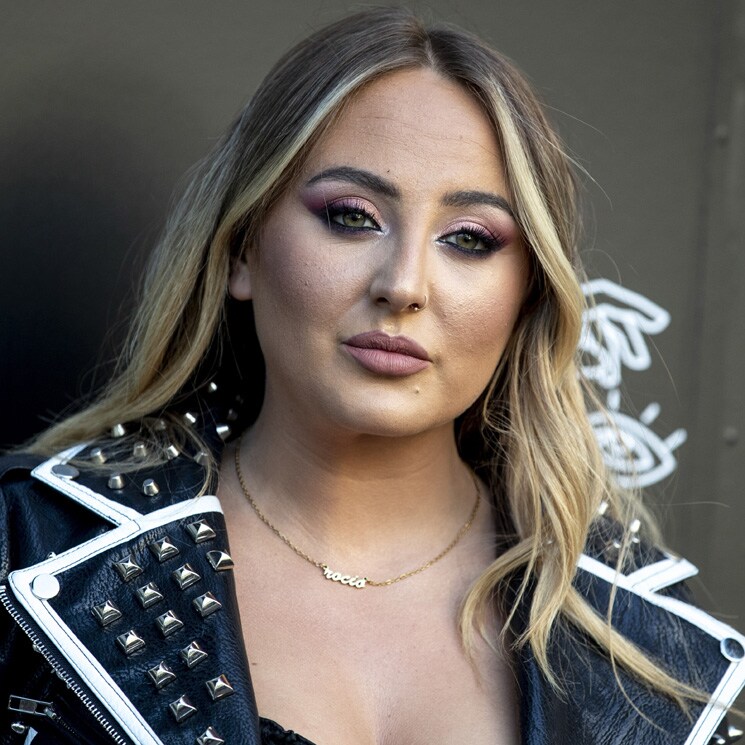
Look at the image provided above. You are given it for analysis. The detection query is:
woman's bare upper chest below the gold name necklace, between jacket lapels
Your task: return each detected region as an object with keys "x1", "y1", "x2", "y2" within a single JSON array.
[{"x1": 234, "y1": 532, "x2": 519, "y2": 745}]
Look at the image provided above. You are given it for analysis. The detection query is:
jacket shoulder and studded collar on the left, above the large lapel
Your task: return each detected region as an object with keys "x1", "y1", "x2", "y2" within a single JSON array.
[{"x1": 0, "y1": 406, "x2": 224, "y2": 568}]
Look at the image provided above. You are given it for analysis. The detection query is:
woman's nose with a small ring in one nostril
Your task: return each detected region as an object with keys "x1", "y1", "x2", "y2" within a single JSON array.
[{"x1": 370, "y1": 238, "x2": 430, "y2": 313}]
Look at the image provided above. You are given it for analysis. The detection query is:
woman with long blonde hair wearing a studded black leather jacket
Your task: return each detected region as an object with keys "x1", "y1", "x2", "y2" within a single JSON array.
[{"x1": 0, "y1": 9, "x2": 745, "y2": 745}]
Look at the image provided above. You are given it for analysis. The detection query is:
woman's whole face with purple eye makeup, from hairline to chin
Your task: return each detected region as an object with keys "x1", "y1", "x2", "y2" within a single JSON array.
[{"x1": 230, "y1": 69, "x2": 529, "y2": 435}]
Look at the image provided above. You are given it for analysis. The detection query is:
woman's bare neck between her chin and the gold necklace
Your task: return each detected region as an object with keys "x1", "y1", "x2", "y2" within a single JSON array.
[{"x1": 232, "y1": 410, "x2": 486, "y2": 571}]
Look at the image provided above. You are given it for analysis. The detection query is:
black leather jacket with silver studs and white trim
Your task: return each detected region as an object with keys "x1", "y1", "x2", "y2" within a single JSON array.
[{"x1": 0, "y1": 402, "x2": 745, "y2": 745}]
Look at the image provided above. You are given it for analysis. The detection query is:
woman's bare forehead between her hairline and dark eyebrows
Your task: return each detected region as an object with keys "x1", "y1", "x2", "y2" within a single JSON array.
[{"x1": 303, "y1": 69, "x2": 508, "y2": 195}]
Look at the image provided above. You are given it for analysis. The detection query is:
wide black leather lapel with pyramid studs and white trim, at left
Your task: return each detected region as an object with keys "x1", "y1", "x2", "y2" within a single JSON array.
[{"x1": 8, "y1": 444, "x2": 259, "y2": 745}]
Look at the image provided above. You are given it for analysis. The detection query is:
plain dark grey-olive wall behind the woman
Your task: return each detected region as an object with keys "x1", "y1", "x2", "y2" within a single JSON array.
[{"x1": 0, "y1": 0, "x2": 745, "y2": 640}]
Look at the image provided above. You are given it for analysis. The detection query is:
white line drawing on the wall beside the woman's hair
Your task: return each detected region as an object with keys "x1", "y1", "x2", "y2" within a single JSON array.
[{"x1": 579, "y1": 279, "x2": 687, "y2": 487}]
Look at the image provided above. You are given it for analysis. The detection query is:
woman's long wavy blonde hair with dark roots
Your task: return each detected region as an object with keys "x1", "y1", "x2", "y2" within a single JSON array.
[{"x1": 29, "y1": 8, "x2": 701, "y2": 708}]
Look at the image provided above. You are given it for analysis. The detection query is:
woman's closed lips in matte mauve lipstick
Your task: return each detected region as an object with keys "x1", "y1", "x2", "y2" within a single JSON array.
[{"x1": 344, "y1": 331, "x2": 431, "y2": 377}]
